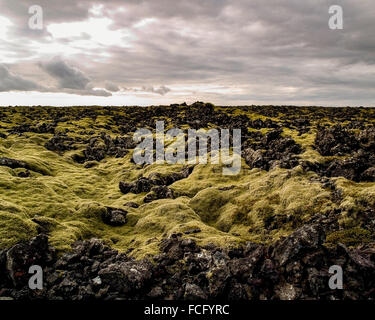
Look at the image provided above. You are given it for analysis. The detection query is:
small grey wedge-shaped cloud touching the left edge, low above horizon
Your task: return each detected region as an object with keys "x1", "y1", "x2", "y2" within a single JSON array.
[{"x1": 0, "y1": 65, "x2": 42, "y2": 92}]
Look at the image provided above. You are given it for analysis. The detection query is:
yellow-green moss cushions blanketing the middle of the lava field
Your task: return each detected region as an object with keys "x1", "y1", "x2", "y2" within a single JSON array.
[{"x1": 0, "y1": 107, "x2": 375, "y2": 258}]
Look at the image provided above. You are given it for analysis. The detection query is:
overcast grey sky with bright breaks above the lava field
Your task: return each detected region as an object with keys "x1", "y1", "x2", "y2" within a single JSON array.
[{"x1": 0, "y1": 0, "x2": 375, "y2": 106}]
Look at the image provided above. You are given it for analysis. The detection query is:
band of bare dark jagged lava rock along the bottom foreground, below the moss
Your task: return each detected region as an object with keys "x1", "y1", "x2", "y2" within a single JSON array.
[{"x1": 0, "y1": 224, "x2": 375, "y2": 300}]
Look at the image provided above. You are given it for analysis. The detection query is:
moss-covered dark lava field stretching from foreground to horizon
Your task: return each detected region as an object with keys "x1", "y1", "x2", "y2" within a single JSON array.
[{"x1": 0, "y1": 102, "x2": 375, "y2": 300}]
